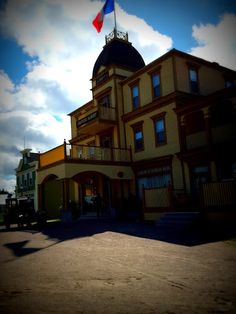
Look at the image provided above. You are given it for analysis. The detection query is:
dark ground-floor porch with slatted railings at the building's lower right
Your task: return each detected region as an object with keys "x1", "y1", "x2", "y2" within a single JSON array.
[{"x1": 143, "y1": 181, "x2": 236, "y2": 222}]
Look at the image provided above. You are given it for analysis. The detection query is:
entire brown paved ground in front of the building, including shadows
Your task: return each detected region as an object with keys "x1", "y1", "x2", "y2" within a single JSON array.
[{"x1": 0, "y1": 221, "x2": 236, "y2": 314}]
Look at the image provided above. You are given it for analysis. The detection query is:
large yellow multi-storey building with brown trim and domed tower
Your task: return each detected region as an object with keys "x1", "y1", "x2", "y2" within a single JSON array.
[{"x1": 38, "y1": 30, "x2": 236, "y2": 219}]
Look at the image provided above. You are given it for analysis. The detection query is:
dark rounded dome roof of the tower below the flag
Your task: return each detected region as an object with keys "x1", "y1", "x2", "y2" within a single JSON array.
[{"x1": 93, "y1": 37, "x2": 145, "y2": 77}]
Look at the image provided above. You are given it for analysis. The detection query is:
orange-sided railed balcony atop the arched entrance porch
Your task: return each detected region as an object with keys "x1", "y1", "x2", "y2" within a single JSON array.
[{"x1": 39, "y1": 142, "x2": 131, "y2": 169}]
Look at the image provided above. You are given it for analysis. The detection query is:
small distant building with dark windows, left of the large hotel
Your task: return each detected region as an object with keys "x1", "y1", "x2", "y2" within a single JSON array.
[{"x1": 16, "y1": 148, "x2": 40, "y2": 210}]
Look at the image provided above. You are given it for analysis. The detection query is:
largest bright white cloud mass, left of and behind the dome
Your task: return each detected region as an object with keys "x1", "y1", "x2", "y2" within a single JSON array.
[{"x1": 0, "y1": 0, "x2": 172, "y2": 188}]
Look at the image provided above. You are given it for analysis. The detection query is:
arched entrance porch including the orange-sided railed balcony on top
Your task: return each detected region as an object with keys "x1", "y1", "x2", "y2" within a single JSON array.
[{"x1": 38, "y1": 142, "x2": 134, "y2": 218}]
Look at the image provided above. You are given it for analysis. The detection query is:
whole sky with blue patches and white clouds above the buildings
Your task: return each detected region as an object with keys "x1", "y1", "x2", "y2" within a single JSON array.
[{"x1": 0, "y1": 0, "x2": 236, "y2": 192}]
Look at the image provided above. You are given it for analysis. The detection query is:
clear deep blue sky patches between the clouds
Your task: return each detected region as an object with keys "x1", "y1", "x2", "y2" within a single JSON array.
[{"x1": 0, "y1": 0, "x2": 236, "y2": 83}]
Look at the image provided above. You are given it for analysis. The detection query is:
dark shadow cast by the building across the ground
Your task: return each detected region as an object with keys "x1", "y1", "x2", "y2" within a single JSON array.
[{"x1": 1, "y1": 220, "x2": 236, "y2": 257}]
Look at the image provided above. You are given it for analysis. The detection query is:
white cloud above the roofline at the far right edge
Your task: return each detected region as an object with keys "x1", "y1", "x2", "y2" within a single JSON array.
[{"x1": 190, "y1": 13, "x2": 236, "y2": 70}]
